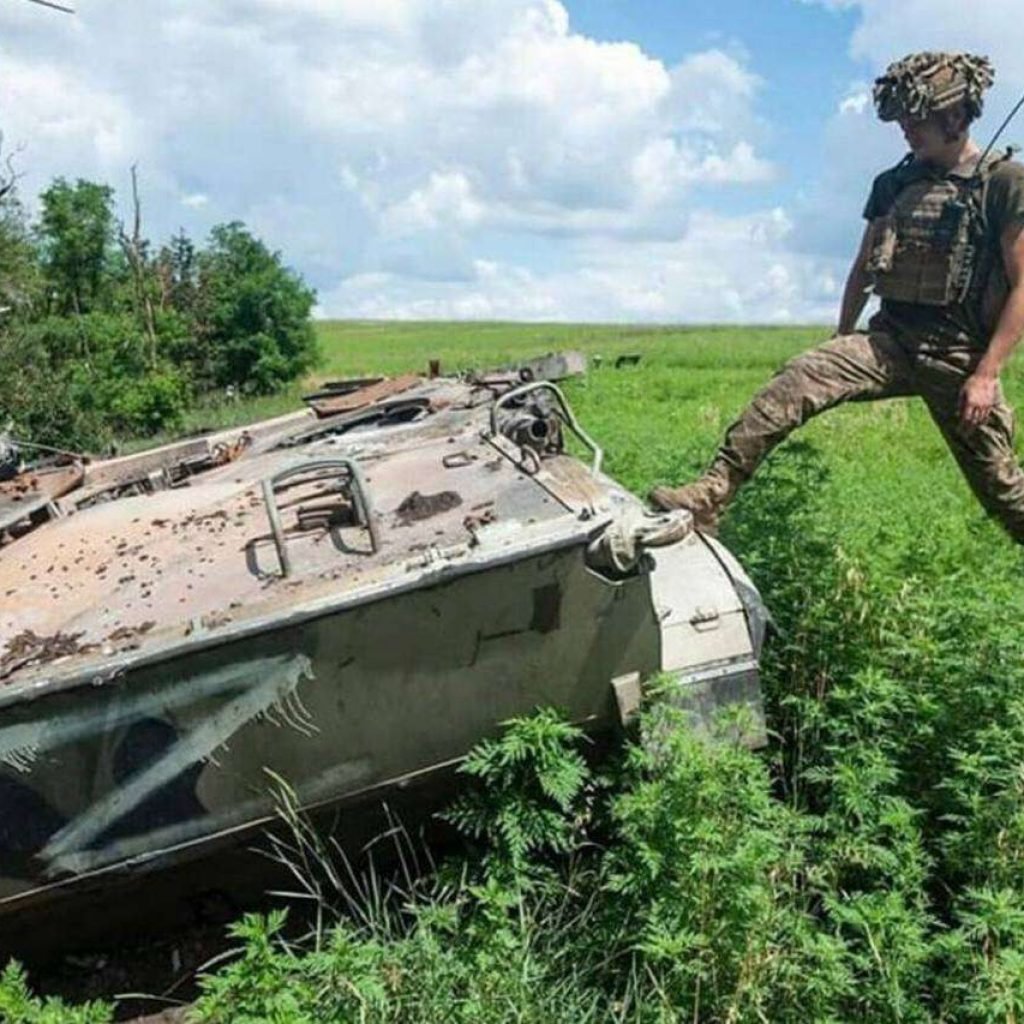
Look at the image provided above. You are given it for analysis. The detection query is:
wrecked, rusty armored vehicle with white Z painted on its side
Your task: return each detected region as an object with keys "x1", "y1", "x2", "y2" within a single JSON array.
[{"x1": 0, "y1": 360, "x2": 765, "y2": 937}]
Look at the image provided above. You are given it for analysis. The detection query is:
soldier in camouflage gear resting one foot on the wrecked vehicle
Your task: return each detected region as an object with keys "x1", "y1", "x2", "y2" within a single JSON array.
[{"x1": 648, "y1": 52, "x2": 1024, "y2": 543}]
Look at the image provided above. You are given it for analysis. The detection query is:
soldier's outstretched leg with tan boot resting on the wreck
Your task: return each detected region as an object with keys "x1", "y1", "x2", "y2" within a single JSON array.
[{"x1": 649, "y1": 334, "x2": 913, "y2": 530}]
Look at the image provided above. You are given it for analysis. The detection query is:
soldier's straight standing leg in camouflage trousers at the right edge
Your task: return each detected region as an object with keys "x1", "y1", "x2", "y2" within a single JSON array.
[{"x1": 919, "y1": 356, "x2": 1024, "y2": 544}]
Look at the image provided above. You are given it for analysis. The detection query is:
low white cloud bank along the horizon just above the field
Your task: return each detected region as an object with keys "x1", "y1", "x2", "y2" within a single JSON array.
[{"x1": 324, "y1": 210, "x2": 840, "y2": 323}]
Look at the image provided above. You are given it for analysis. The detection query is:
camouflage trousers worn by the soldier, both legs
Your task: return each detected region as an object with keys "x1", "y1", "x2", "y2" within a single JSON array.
[{"x1": 705, "y1": 332, "x2": 1024, "y2": 543}]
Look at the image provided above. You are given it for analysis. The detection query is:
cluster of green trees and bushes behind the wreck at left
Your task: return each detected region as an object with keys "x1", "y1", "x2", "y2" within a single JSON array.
[{"x1": 0, "y1": 156, "x2": 317, "y2": 451}]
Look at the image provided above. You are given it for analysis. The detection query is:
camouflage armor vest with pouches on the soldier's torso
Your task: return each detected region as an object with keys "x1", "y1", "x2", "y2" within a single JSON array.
[{"x1": 867, "y1": 157, "x2": 988, "y2": 306}]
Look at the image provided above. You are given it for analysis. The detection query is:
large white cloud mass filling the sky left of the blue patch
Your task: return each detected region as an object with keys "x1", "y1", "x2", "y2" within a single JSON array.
[{"x1": 0, "y1": 0, "x2": 790, "y2": 318}]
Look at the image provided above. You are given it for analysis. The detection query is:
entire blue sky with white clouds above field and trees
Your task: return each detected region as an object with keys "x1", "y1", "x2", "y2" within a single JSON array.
[{"x1": 0, "y1": 0, "x2": 1024, "y2": 324}]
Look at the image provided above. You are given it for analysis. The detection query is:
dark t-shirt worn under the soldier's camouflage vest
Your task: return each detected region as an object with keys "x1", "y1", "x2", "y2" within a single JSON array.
[{"x1": 864, "y1": 149, "x2": 1024, "y2": 348}]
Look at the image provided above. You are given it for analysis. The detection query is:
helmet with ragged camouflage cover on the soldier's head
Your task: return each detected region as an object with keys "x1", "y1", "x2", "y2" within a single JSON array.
[{"x1": 874, "y1": 51, "x2": 995, "y2": 121}]
